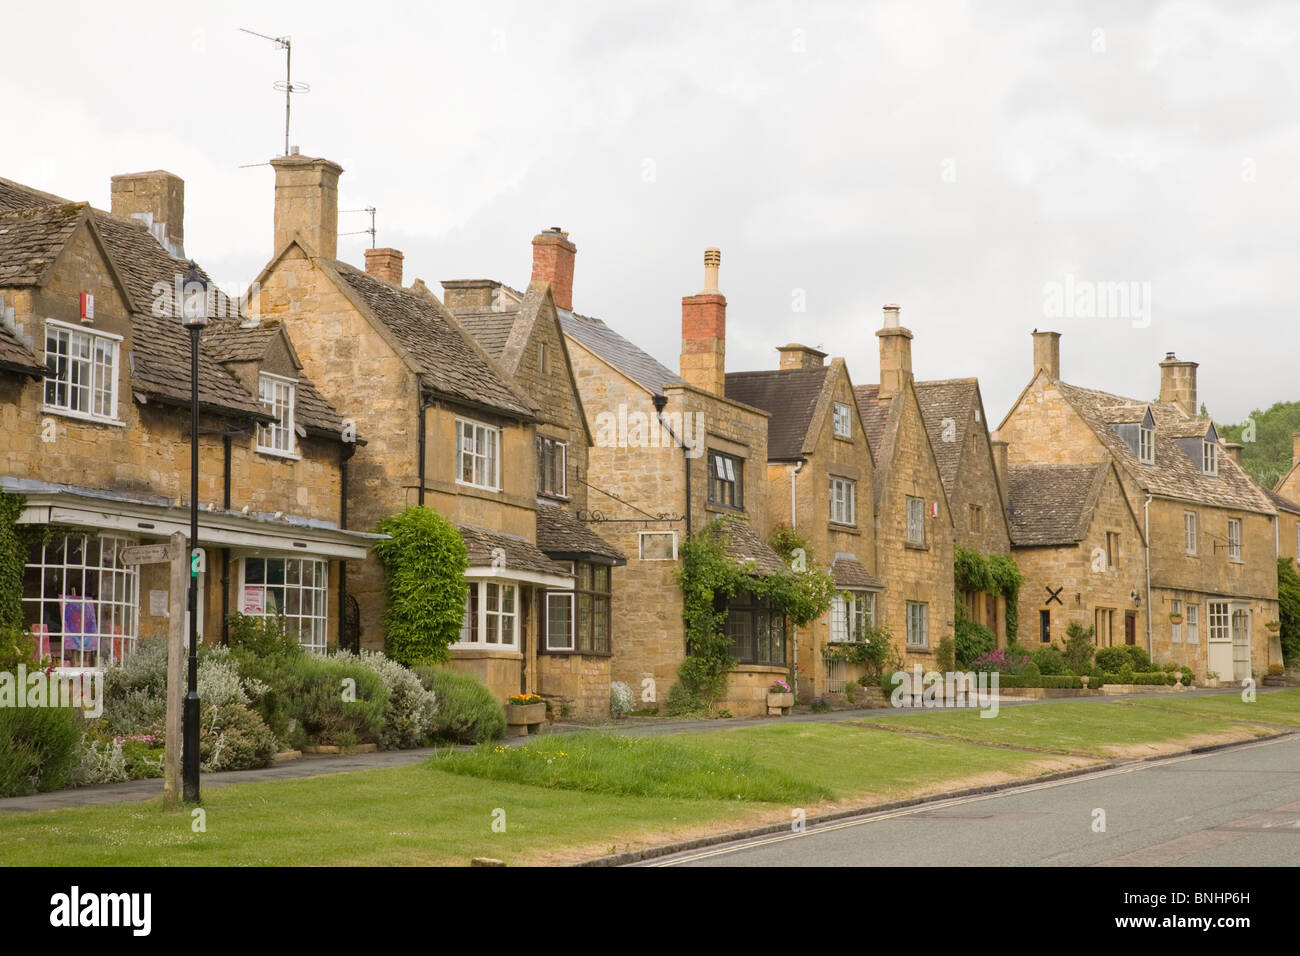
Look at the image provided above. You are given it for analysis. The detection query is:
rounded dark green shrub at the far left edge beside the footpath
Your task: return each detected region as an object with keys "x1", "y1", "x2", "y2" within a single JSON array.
[{"x1": 0, "y1": 708, "x2": 83, "y2": 796}]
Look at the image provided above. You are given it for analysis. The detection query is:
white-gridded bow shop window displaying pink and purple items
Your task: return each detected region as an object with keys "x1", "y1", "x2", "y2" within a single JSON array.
[{"x1": 20, "y1": 532, "x2": 140, "y2": 669}]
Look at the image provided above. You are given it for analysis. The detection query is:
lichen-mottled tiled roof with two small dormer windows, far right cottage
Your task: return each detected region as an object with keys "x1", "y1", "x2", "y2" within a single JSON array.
[{"x1": 1056, "y1": 381, "x2": 1274, "y2": 514}]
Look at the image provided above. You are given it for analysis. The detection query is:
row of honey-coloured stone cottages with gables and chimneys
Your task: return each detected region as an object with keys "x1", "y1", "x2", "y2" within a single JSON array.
[{"x1": 0, "y1": 155, "x2": 1279, "y2": 717}]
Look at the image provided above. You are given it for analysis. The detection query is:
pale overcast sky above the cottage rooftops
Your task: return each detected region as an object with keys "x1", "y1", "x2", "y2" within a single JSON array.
[{"x1": 0, "y1": 0, "x2": 1300, "y2": 424}]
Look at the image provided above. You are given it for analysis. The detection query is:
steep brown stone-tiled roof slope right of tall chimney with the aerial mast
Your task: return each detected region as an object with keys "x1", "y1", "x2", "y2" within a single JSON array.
[{"x1": 330, "y1": 261, "x2": 533, "y2": 419}]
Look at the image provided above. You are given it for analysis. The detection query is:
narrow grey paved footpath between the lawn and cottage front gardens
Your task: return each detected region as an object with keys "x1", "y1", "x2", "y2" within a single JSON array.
[{"x1": 0, "y1": 688, "x2": 1282, "y2": 813}]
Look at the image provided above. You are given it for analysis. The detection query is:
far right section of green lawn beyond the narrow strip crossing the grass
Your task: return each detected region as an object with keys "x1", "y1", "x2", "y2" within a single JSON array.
[{"x1": 866, "y1": 697, "x2": 1269, "y2": 757}]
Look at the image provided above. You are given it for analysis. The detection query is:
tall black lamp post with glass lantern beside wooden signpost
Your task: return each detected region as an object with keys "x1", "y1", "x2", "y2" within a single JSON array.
[{"x1": 181, "y1": 259, "x2": 208, "y2": 803}]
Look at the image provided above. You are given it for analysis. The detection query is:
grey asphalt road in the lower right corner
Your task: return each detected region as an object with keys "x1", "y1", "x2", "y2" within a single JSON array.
[{"x1": 642, "y1": 737, "x2": 1300, "y2": 866}]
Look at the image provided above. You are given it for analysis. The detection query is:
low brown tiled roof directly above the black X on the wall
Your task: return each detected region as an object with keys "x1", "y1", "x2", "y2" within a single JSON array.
[{"x1": 1008, "y1": 460, "x2": 1110, "y2": 548}]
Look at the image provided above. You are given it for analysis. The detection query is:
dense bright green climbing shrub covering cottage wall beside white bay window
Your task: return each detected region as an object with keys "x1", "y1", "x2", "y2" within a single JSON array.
[{"x1": 373, "y1": 506, "x2": 469, "y2": 667}]
